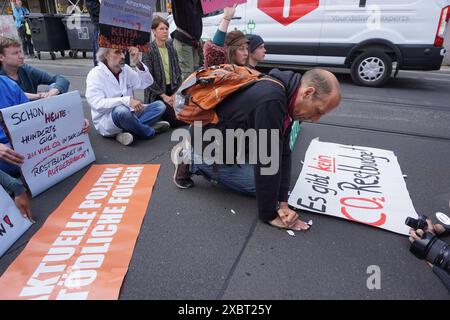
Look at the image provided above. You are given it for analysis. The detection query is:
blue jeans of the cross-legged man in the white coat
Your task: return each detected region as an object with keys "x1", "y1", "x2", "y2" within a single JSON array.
[{"x1": 111, "y1": 101, "x2": 166, "y2": 139}]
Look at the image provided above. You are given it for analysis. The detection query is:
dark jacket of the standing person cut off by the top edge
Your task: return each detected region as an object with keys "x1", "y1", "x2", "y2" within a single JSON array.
[{"x1": 171, "y1": 0, "x2": 203, "y2": 47}]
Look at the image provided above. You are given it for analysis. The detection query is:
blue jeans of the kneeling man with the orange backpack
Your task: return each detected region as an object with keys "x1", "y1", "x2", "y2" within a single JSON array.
[{"x1": 191, "y1": 158, "x2": 256, "y2": 197}]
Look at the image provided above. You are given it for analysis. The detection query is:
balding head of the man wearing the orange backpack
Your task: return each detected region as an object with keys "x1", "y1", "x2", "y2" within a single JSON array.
[{"x1": 293, "y1": 69, "x2": 341, "y2": 122}]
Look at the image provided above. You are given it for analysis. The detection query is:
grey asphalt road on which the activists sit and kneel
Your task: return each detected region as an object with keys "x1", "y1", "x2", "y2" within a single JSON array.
[{"x1": 0, "y1": 56, "x2": 450, "y2": 300}]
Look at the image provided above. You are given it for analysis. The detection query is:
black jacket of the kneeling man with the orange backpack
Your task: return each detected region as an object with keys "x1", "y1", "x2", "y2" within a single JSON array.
[{"x1": 216, "y1": 69, "x2": 301, "y2": 221}]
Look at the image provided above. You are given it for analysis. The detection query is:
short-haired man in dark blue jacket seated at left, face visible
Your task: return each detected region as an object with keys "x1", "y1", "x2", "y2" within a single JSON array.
[{"x1": 0, "y1": 37, "x2": 70, "y2": 101}]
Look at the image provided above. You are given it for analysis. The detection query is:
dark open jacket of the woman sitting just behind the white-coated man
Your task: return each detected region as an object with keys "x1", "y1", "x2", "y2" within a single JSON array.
[{"x1": 142, "y1": 41, "x2": 182, "y2": 103}]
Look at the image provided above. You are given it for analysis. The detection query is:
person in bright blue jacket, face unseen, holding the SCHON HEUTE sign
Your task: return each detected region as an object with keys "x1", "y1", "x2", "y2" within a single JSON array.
[{"x1": 0, "y1": 76, "x2": 89, "y2": 178}]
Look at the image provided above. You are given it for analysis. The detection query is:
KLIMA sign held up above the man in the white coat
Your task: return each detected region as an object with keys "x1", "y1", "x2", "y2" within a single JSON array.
[{"x1": 99, "y1": 0, "x2": 155, "y2": 52}]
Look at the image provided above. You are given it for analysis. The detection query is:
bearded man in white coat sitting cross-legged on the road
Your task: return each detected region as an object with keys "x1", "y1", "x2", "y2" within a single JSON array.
[{"x1": 86, "y1": 47, "x2": 170, "y2": 145}]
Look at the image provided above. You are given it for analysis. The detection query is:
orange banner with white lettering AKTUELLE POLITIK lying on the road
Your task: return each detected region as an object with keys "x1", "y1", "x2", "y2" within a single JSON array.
[{"x1": 0, "y1": 165, "x2": 159, "y2": 300}]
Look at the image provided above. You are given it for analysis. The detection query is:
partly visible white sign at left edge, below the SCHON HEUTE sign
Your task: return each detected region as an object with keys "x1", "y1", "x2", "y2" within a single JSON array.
[{"x1": 0, "y1": 186, "x2": 31, "y2": 257}]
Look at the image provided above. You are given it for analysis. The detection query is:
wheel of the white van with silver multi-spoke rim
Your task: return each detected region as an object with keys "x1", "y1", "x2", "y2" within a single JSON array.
[{"x1": 351, "y1": 50, "x2": 392, "y2": 87}]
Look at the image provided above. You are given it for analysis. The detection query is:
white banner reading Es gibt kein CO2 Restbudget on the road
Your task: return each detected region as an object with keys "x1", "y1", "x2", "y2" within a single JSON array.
[{"x1": 289, "y1": 140, "x2": 418, "y2": 235}]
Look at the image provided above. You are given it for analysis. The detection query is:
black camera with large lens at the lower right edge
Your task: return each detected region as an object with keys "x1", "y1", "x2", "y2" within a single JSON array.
[{"x1": 405, "y1": 215, "x2": 450, "y2": 274}]
